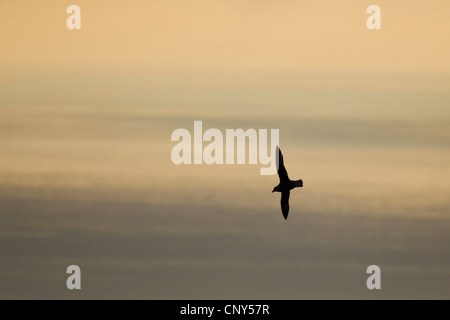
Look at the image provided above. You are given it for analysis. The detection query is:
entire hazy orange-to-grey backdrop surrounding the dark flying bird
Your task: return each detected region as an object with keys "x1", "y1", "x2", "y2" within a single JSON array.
[{"x1": 0, "y1": 0, "x2": 450, "y2": 299}]
